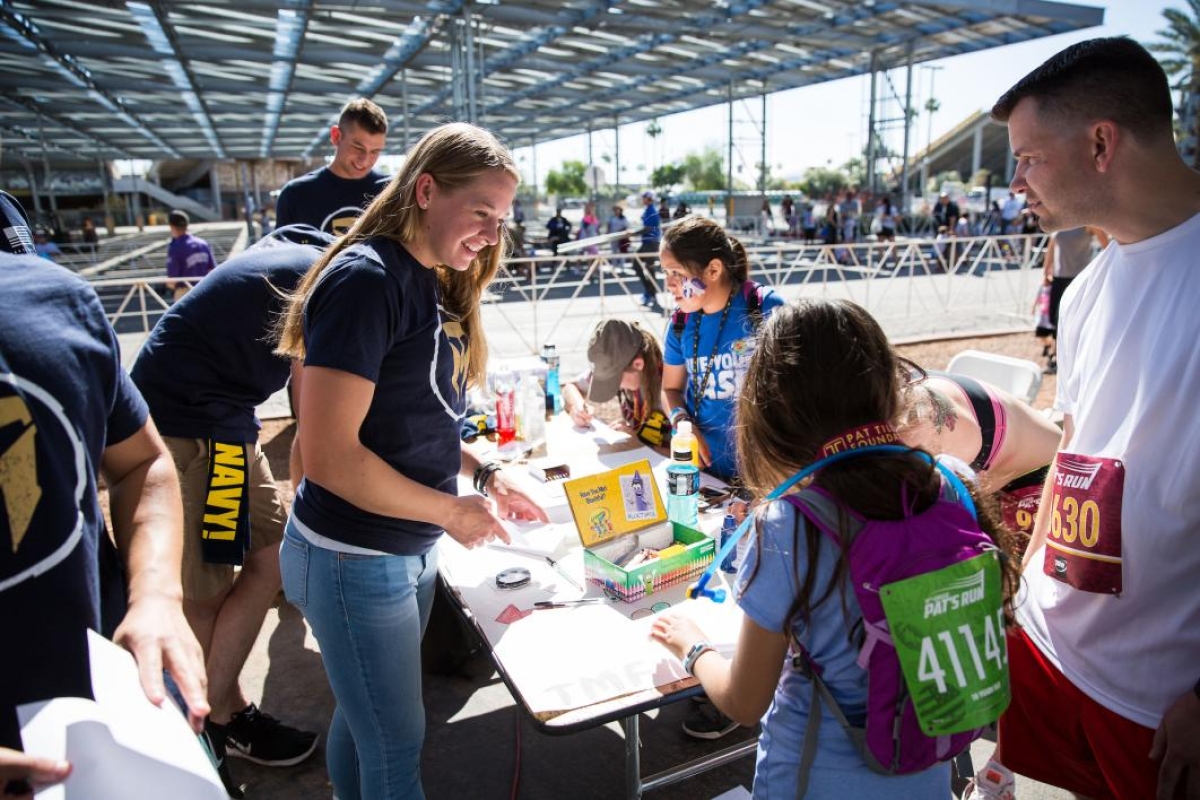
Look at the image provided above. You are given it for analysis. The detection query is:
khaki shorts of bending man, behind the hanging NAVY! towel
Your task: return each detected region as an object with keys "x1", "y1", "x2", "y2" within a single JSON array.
[{"x1": 162, "y1": 437, "x2": 288, "y2": 600}]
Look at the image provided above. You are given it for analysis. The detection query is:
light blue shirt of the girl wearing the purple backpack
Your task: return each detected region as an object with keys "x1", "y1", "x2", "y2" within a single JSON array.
[{"x1": 738, "y1": 500, "x2": 950, "y2": 800}]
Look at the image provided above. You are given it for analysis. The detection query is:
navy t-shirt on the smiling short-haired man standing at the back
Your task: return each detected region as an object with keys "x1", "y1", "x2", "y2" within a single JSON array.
[{"x1": 275, "y1": 167, "x2": 391, "y2": 236}]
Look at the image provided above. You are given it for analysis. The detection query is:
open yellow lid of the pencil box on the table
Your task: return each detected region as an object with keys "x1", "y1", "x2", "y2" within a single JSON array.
[{"x1": 563, "y1": 458, "x2": 666, "y2": 547}]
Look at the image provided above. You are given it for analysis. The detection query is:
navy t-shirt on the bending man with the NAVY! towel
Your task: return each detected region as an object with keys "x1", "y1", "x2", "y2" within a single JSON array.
[{"x1": 133, "y1": 230, "x2": 334, "y2": 441}]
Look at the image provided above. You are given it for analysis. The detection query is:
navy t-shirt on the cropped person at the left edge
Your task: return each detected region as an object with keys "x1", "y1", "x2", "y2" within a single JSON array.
[{"x1": 0, "y1": 253, "x2": 146, "y2": 748}]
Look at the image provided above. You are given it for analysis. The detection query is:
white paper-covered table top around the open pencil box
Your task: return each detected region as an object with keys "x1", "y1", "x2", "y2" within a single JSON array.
[{"x1": 439, "y1": 415, "x2": 742, "y2": 720}]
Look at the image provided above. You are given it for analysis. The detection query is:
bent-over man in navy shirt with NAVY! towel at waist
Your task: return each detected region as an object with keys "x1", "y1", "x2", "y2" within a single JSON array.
[{"x1": 132, "y1": 225, "x2": 334, "y2": 796}]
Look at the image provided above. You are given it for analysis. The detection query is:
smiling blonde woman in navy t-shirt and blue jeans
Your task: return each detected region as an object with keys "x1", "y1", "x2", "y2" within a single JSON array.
[{"x1": 280, "y1": 124, "x2": 546, "y2": 800}]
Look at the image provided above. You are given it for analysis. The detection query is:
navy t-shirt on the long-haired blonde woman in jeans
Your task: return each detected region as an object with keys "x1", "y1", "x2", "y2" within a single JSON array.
[{"x1": 294, "y1": 239, "x2": 468, "y2": 555}]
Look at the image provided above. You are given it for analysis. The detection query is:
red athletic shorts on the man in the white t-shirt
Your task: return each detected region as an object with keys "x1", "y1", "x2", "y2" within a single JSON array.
[{"x1": 997, "y1": 630, "x2": 1158, "y2": 800}]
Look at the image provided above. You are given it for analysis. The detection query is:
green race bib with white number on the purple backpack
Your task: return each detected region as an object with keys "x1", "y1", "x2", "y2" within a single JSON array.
[{"x1": 880, "y1": 553, "x2": 1010, "y2": 736}]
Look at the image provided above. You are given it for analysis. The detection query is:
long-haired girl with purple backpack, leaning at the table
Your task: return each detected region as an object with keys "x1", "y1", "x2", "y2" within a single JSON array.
[{"x1": 652, "y1": 300, "x2": 1016, "y2": 800}]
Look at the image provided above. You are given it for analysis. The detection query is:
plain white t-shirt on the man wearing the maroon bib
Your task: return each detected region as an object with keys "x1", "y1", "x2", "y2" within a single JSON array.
[{"x1": 1019, "y1": 209, "x2": 1200, "y2": 728}]
